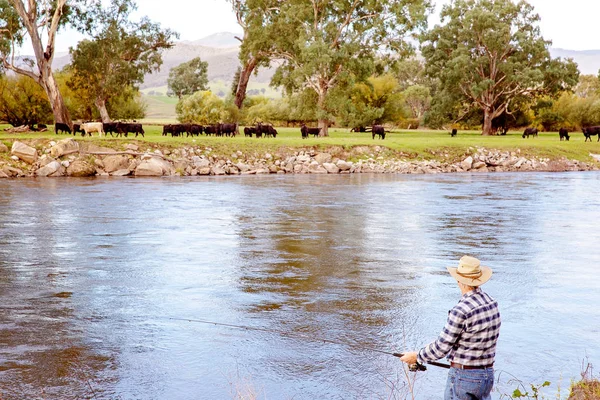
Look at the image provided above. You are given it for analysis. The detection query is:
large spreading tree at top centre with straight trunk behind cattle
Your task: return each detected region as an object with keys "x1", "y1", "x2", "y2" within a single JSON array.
[{"x1": 246, "y1": 0, "x2": 430, "y2": 136}]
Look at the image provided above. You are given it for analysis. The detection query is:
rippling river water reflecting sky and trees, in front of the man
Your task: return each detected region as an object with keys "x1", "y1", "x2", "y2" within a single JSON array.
[{"x1": 0, "y1": 172, "x2": 600, "y2": 400}]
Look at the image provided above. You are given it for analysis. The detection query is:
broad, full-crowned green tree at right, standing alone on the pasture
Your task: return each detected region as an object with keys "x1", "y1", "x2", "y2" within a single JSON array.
[{"x1": 421, "y1": 0, "x2": 578, "y2": 135}]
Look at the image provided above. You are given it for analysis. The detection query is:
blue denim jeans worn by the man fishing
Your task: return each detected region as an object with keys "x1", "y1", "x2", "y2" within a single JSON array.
[{"x1": 444, "y1": 368, "x2": 494, "y2": 400}]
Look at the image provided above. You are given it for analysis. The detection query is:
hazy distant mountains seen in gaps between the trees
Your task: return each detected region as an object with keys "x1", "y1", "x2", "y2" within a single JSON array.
[{"x1": 47, "y1": 32, "x2": 600, "y2": 89}]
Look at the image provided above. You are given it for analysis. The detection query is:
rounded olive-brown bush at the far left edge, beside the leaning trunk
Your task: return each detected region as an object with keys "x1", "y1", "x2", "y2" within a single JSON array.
[{"x1": 0, "y1": 76, "x2": 52, "y2": 126}]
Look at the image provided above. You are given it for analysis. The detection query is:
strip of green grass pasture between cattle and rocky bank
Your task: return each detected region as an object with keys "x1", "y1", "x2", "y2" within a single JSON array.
[{"x1": 0, "y1": 124, "x2": 600, "y2": 161}]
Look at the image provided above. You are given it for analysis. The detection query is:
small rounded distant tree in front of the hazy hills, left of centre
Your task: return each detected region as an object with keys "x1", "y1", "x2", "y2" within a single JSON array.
[{"x1": 167, "y1": 57, "x2": 208, "y2": 100}]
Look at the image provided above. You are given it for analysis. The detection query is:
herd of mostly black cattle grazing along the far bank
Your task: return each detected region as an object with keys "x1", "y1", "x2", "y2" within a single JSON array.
[{"x1": 54, "y1": 122, "x2": 600, "y2": 142}]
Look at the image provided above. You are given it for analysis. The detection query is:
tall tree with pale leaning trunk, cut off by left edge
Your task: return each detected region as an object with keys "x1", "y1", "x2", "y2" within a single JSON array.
[{"x1": 0, "y1": 0, "x2": 77, "y2": 124}]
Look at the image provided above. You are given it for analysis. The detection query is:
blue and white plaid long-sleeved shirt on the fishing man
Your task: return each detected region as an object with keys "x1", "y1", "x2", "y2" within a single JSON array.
[{"x1": 417, "y1": 288, "x2": 500, "y2": 366}]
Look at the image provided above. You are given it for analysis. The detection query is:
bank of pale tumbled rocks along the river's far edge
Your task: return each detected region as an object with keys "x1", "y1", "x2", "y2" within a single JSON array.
[{"x1": 0, "y1": 138, "x2": 600, "y2": 178}]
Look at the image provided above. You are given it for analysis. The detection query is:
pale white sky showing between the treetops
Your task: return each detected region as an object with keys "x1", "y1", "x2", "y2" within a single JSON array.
[{"x1": 45, "y1": 0, "x2": 600, "y2": 51}]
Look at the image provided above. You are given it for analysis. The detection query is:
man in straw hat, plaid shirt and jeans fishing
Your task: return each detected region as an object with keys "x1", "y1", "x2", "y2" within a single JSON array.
[{"x1": 400, "y1": 256, "x2": 500, "y2": 400}]
